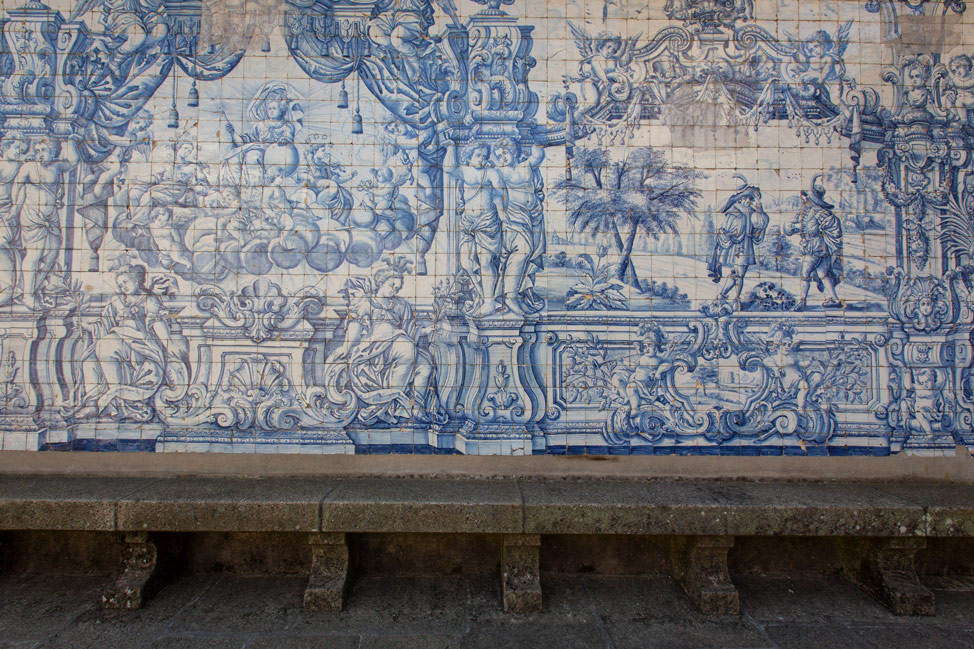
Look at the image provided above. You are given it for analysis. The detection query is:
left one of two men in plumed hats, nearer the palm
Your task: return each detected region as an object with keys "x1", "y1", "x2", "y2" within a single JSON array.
[{"x1": 707, "y1": 178, "x2": 769, "y2": 302}]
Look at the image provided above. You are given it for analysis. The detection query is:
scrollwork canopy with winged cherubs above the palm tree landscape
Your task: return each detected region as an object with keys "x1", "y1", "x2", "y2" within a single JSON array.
[{"x1": 549, "y1": 10, "x2": 860, "y2": 141}]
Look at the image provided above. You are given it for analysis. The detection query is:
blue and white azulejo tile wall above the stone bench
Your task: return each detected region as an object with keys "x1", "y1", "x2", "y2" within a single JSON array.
[{"x1": 0, "y1": 0, "x2": 974, "y2": 456}]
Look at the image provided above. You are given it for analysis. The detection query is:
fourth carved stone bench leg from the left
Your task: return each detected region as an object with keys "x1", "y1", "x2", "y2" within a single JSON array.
[{"x1": 670, "y1": 536, "x2": 741, "y2": 615}]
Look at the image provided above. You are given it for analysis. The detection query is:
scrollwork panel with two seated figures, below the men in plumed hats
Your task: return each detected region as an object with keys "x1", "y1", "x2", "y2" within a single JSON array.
[{"x1": 560, "y1": 318, "x2": 883, "y2": 444}]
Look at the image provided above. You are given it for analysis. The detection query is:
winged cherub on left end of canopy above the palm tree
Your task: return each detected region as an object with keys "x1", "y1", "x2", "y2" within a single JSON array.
[{"x1": 568, "y1": 22, "x2": 642, "y2": 107}]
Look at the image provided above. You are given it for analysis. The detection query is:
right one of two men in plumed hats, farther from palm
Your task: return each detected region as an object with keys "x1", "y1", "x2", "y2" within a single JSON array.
[{"x1": 785, "y1": 174, "x2": 842, "y2": 311}]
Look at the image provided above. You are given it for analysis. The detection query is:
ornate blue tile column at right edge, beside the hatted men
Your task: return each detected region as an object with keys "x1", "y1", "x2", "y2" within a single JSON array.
[{"x1": 878, "y1": 55, "x2": 974, "y2": 454}]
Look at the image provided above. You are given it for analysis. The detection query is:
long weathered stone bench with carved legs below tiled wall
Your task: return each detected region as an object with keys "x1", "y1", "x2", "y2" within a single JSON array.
[{"x1": 0, "y1": 475, "x2": 974, "y2": 615}]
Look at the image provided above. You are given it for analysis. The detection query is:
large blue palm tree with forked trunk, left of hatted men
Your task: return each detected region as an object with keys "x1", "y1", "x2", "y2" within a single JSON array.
[{"x1": 555, "y1": 147, "x2": 703, "y2": 288}]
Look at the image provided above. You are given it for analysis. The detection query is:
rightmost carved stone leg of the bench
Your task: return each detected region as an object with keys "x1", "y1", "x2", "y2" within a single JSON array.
[{"x1": 842, "y1": 537, "x2": 935, "y2": 615}]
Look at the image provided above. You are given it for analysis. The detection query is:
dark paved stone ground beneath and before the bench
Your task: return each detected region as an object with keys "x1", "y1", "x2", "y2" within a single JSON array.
[{"x1": 0, "y1": 574, "x2": 974, "y2": 649}]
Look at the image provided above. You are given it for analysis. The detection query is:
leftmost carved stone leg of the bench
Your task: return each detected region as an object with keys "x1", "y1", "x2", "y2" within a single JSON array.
[{"x1": 101, "y1": 532, "x2": 168, "y2": 609}]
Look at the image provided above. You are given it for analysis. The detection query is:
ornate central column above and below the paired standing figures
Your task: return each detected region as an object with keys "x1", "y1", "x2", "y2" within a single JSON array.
[{"x1": 446, "y1": 0, "x2": 545, "y2": 455}]
